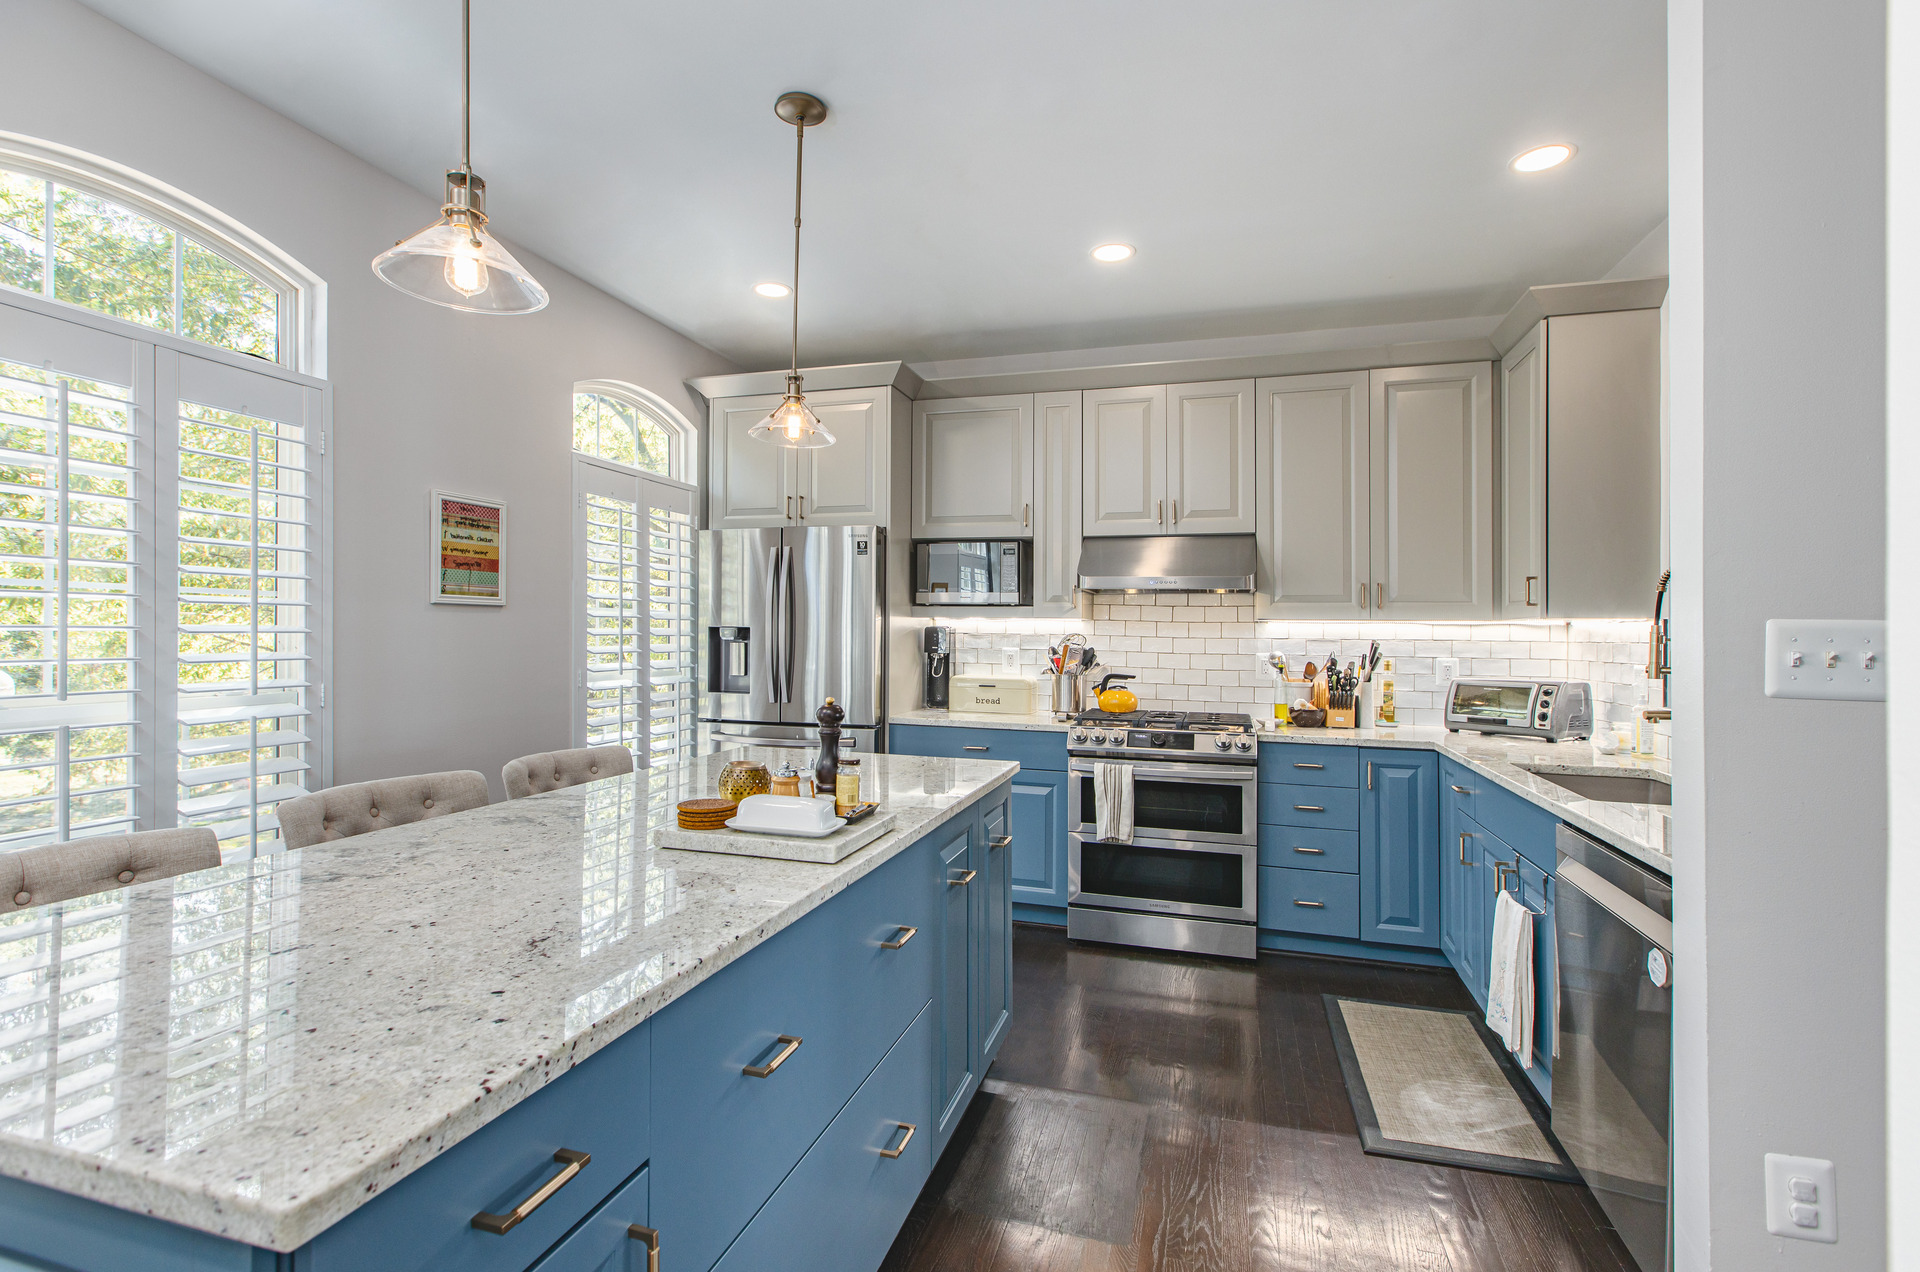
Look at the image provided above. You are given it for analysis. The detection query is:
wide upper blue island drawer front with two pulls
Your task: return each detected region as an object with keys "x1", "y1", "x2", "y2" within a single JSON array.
[{"x1": 653, "y1": 845, "x2": 939, "y2": 1272}]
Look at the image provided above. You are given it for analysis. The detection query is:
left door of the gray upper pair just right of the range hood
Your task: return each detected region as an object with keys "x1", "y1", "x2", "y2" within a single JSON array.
[{"x1": 1254, "y1": 371, "x2": 1373, "y2": 619}]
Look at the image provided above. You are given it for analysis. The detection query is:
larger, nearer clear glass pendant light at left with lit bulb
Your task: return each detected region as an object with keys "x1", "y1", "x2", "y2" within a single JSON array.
[{"x1": 372, "y1": 0, "x2": 547, "y2": 313}]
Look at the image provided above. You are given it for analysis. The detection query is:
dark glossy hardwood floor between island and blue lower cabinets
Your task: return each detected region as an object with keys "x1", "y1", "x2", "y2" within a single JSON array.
[{"x1": 881, "y1": 924, "x2": 1634, "y2": 1272}]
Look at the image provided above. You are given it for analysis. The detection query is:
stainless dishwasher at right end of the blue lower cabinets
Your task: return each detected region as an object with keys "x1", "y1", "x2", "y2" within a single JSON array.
[{"x1": 1553, "y1": 826, "x2": 1674, "y2": 1272}]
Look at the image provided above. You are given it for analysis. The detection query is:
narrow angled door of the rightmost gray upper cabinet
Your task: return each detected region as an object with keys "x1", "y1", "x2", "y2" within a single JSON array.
[{"x1": 1500, "y1": 321, "x2": 1543, "y2": 619}]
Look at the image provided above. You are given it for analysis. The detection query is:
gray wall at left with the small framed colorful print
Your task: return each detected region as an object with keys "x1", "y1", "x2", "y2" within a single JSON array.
[{"x1": 0, "y1": 0, "x2": 733, "y2": 797}]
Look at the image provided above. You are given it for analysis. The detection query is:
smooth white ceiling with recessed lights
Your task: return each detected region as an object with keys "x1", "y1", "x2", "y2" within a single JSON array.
[{"x1": 84, "y1": 0, "x2": 1667, "y2": 367}]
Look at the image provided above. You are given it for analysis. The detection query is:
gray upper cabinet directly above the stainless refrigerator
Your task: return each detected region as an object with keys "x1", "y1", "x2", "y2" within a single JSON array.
[{"x1": 707, "y1": 388, "x2": 897, "y2": 530}]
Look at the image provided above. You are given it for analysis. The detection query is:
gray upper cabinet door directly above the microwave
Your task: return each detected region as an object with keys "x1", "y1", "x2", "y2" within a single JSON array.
[{"x1": 914, "y1": 394, "x2": 1036, "y2": 538}]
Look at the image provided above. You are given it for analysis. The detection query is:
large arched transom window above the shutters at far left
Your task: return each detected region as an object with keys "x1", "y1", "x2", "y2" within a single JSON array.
[{"x1": 0, "y1": 136, "x2": 317, "y2": 371}]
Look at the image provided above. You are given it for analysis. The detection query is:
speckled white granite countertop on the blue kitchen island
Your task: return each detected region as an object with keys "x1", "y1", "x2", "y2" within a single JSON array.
[{"x1": 0, "y1": 749, "x2": 1016, "y2": 1251}]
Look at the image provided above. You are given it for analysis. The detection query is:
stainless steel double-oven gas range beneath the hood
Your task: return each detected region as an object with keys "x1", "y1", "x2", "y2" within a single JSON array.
[{"x1": 1068, "y1": 711, "x2": 1260, "y2": 959}]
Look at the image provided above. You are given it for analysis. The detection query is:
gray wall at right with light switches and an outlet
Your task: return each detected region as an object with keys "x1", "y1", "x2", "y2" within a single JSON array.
[{"x1": 1668, "y1": 0, "x2": 1887, "y2": 1272}]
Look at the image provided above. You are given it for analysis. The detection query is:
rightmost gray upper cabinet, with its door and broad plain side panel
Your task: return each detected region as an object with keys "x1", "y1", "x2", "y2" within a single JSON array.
[{"x1": 1500, "y1": 309, "x2": 1663, "y2": 619}]
